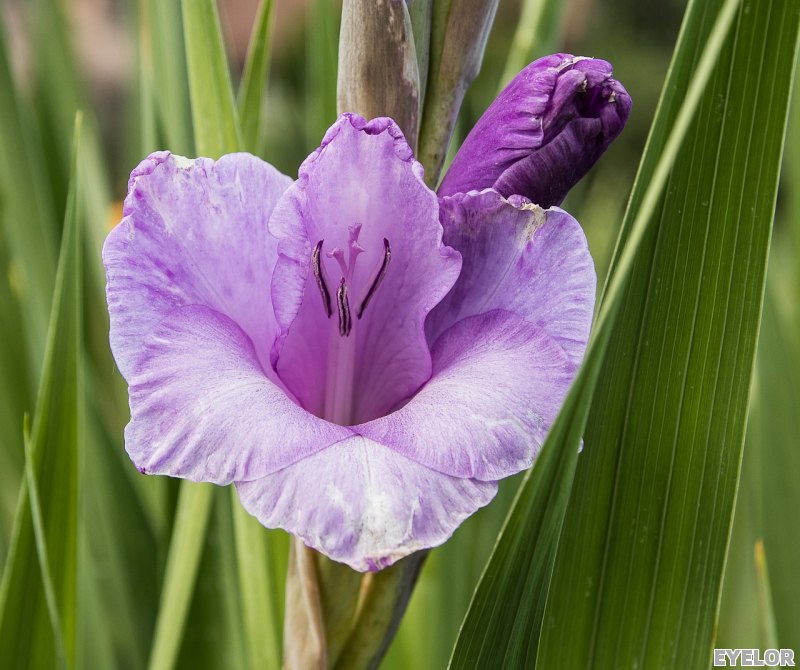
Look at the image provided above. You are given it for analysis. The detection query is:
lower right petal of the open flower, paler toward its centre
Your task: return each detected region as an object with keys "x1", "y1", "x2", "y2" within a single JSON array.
[{"x1": 354, "y1": 310, "x2": 576, "y2": 481}]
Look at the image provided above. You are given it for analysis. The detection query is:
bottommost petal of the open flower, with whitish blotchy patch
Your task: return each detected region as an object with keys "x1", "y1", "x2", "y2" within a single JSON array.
[{"x1": 236, "y1": 437, "x2": 497, "y2": 572}]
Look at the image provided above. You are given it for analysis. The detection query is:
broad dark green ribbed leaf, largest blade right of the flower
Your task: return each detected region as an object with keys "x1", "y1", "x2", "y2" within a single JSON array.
[{"x1": 538, "y1": 0, "x2": 800, "y2": 668}]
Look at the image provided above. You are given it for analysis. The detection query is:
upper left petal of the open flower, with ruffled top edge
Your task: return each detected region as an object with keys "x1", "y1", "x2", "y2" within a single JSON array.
[{"x1": 103, "y1": 152, "x2": 291, "y2": 380}]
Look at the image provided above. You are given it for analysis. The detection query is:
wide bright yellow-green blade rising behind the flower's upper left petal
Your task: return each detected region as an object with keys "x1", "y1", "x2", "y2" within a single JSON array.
[{"x1": 181, "y1": 0, "x2": 242, "y2": 158}]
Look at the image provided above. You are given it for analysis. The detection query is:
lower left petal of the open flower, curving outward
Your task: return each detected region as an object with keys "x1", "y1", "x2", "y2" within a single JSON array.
[{"x1": 125, "y1": 305, "x2": 352, "y2": 488}]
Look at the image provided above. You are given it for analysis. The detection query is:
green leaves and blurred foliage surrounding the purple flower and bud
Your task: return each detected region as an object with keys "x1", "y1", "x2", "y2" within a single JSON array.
[{"x1": 0, "y1": 0, "x2": 800, "y2": 669}]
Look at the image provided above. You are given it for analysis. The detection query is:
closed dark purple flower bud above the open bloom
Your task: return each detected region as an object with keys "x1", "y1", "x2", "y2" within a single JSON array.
[{"x1": 439, "y1": 54, "x2": 631, "y2": 207}]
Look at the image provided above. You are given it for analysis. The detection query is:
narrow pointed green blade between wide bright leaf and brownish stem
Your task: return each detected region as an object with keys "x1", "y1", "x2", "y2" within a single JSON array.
[{"x1": 238, "y1": 0, "x2": 273, "y2": 154}]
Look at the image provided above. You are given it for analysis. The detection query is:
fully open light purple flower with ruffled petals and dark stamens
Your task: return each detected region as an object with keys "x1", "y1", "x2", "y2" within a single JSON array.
[{"x1": 103, "y1": 53, "x2": 628, "y2": 570}]
